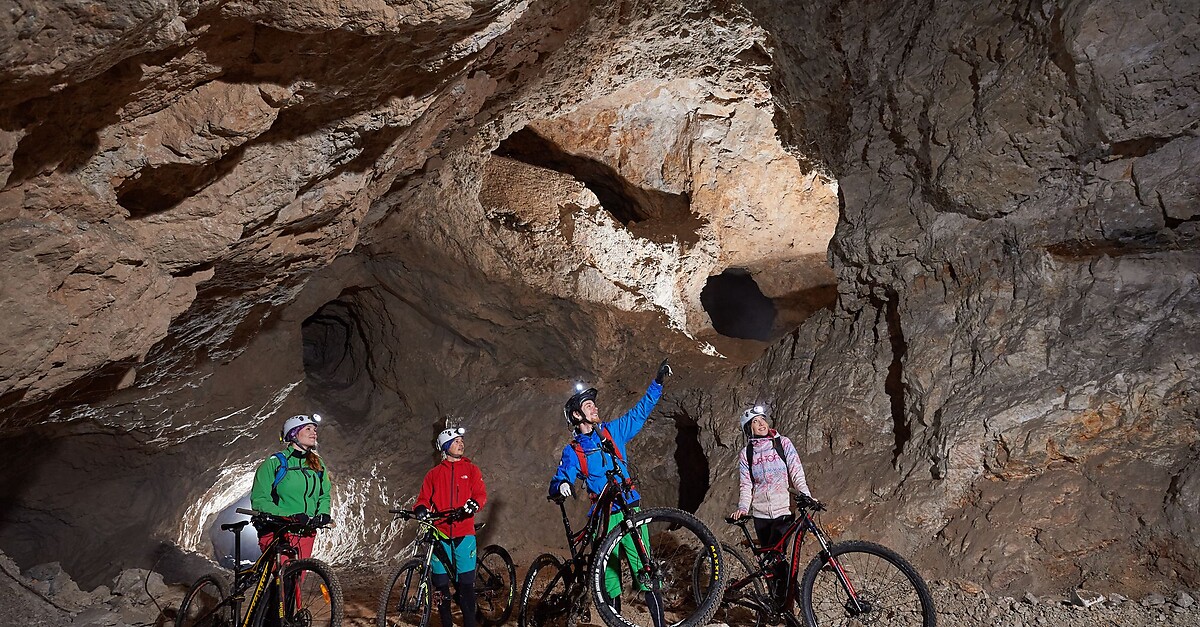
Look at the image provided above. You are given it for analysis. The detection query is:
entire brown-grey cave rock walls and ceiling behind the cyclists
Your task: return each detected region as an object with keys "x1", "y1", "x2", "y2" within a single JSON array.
[{"x1": 0, "y1": 0, "x2": 1200, "y2": 593}]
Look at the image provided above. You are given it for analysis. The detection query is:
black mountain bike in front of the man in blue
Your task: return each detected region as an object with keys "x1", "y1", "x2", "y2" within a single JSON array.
[{"x1": 517, "y1": 441, "x2": 725, "y2": 627}]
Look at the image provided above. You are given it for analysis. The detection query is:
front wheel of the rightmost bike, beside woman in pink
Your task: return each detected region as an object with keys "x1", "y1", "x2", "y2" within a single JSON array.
[{"x1": 800, "y1": 541, "x2": 937, "y2": 627}]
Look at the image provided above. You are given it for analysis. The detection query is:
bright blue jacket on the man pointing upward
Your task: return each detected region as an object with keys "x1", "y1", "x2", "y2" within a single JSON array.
[{"x1": 550, "y1": 381, "x2": 662, "y2": 502}]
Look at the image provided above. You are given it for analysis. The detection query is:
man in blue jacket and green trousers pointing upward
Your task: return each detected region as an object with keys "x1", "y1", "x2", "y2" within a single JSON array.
[{"x1": 550, "y1": 359, "x2": 672, "y2": 627}]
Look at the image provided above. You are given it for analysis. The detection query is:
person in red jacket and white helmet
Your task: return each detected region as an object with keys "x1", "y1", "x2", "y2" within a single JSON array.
[{"x1": 414, "y1": 426, "x2": 487, "y2": 627}]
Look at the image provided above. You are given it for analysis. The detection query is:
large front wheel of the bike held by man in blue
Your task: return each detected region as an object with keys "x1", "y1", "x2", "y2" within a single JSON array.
[{"x1": 588, "y1": 507, "x2": 726, "y2": 627}]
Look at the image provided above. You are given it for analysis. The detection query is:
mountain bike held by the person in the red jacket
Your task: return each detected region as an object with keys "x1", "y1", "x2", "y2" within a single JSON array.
[{"x1": 376, "y1": 509, "x2": 517, "y2": 627}]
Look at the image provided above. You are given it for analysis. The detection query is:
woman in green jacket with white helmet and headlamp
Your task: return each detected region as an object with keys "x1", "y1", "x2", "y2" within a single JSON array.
[{"x1": 250, "y1": 413, "x2": 331, "y2": 557}]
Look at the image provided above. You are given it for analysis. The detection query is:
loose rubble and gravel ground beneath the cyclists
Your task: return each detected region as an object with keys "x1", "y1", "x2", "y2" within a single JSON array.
[{"x1": 0, "y1": 542, "x2": 1200, "y2": 627}]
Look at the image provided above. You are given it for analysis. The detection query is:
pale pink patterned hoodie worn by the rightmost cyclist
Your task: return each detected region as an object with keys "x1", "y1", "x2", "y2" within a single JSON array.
[{"x1": 738, "y1": 429, "x2": 812, "y2": 518}]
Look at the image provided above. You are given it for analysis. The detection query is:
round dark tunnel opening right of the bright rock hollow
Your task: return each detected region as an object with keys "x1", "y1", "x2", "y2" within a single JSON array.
[{"x1": 700, "y1": 268, "x2": 776, "y2": 341}]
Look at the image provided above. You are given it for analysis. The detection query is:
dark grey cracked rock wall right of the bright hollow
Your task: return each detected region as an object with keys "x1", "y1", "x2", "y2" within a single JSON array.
[{"x1": 729, "y1": 1, "x2": 1200, "y2": 587}]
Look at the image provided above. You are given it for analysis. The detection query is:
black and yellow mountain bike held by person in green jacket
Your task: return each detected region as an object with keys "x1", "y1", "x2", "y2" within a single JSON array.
[{"x1": 175, "y1": 508, "x2": 342, "y2": 627}]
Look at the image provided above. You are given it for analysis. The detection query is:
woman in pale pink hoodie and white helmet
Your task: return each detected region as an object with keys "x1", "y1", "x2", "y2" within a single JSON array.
[{"x1": 730, "y1": 406, "x2": 812, "y2": 595}]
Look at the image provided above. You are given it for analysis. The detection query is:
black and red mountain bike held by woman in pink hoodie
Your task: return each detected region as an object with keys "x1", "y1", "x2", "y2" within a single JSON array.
[{"x1": 694, "y1": 494, "x2": 937, "y2": 627}]
